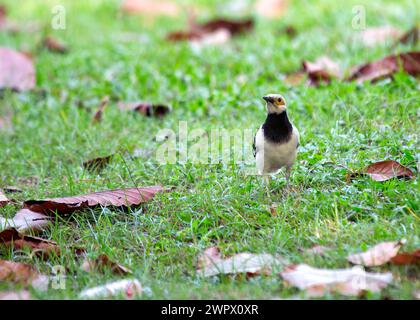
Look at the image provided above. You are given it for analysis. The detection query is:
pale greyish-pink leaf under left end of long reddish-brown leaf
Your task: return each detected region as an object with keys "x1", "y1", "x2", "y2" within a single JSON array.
[{"x1": 0, "y1": 208, "x2": 50, "y2": 233}]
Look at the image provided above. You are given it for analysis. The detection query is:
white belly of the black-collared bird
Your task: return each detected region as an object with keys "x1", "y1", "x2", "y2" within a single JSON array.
[{"x1": 255, "y1": 127, "x2": 299, "y2": 175}]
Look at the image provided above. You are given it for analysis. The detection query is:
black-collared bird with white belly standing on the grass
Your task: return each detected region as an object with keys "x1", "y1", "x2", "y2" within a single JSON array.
[{"x1": 252, "y1": 94, "x2": 299, "y2": 188}]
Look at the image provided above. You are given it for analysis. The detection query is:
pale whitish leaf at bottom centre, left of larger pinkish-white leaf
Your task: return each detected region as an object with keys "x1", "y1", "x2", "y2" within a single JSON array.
[{"x1": 197, "y1": 253, "x2": 285, "y2": 277}]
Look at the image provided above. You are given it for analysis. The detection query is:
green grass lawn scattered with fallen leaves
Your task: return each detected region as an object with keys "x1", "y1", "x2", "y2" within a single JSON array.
[{"x1": 0, "y1": 0, "x2": 420, "y2": 299}]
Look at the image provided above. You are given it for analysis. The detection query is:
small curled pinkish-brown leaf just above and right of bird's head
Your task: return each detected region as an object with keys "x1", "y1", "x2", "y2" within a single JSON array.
[{"x1": 302, "y1": 57, "x2": 340, "y2": 85}]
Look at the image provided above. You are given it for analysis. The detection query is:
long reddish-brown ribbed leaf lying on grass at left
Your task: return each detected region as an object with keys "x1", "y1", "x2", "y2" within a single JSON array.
[{"x1": 24, "y1": 186, "x2": 164, "y2": 215}]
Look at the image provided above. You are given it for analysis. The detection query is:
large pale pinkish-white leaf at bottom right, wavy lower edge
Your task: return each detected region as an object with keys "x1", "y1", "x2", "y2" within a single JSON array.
[{"x1": 280, "y1": 264, "x2": 392, "y2": 297}]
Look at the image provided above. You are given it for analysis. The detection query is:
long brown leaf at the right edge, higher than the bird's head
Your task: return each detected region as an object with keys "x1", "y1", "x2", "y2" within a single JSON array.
[{"x1": 346, "y1": 52, "x2": 420, "y2": 82}]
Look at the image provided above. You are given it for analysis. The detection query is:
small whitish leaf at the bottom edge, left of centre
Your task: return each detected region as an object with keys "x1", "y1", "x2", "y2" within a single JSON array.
[{"x1": 79, "y1": 279, "x2": 142, "y2": 299}]
